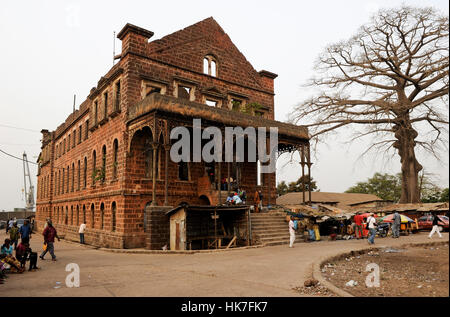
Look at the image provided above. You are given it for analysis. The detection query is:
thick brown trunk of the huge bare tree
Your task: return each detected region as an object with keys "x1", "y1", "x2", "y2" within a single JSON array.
[{"x1": 393, "y1": 115, "x2": 422, "y2": 204}]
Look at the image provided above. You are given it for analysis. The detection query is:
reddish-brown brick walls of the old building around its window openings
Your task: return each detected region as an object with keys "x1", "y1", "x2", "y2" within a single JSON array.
[{"x1": 37, "y1": 19, "x2": 276, "y2": 248}]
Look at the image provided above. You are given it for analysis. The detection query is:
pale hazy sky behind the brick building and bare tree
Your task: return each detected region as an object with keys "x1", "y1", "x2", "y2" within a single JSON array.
[{"x1": 0, "y1": 0, "x2": 449, "y2": 210}]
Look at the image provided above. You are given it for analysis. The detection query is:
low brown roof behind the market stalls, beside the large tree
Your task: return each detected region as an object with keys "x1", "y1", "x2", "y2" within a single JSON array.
[{"x1": 277, "y1": 192, "x2": 382, "y2": 209}]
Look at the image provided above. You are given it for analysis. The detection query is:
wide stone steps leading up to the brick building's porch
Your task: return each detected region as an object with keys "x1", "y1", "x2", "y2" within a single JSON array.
[{"x1": 251, "y1": 212, "x2": 303, "y2": 246}]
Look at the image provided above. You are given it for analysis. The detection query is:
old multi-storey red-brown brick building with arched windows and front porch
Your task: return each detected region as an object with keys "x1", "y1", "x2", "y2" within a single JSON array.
[{"x1": 37, "y1": 18, "x2": 310, "y2": 248}]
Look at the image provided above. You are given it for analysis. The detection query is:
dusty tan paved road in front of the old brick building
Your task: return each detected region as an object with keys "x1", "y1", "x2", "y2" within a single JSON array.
[{"x1": 0, "y1": 231, "x2": 449, "y2": 297}]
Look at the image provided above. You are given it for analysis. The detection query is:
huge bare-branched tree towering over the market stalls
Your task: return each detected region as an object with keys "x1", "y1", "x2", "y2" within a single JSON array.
[{"x1": 291, "y1": 6, "x2": 449, "y2": 203}]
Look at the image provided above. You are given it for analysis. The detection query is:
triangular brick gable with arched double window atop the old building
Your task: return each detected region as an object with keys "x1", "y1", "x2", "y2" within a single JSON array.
[{"x1": 148, "y1": 17, "x2": 268, "y2": 89}]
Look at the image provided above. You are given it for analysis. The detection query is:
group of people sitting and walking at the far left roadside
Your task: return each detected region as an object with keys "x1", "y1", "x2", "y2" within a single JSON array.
[{"x1": 0, "y1": 219, "x2": 60, "y2": 284}]
